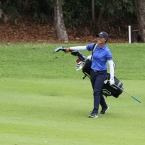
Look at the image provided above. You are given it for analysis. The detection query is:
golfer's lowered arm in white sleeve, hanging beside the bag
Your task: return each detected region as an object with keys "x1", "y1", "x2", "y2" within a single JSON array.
[{"x1": 108, "y1": 60, "x2": 114, "y2": 85}]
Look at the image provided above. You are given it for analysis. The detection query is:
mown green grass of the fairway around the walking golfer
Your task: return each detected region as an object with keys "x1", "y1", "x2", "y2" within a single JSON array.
[{"x1": 0, "y1": 43, "x2": 145, "y2": 145}]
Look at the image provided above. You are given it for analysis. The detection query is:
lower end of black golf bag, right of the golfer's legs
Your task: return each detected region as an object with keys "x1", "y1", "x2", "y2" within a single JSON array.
[{"x1": 102, "y1": 73, "x2": 124, "y2": 98}]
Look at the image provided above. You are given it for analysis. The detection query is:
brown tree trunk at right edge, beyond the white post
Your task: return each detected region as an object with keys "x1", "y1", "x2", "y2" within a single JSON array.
[{"x1": 134, "y1": 0, "x2": 145, "y2": 42}]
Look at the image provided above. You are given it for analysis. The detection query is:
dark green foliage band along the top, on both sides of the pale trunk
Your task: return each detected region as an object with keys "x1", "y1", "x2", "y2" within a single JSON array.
[{"x1": 0, "y1": 0, "x2": 143, "y2": 42}]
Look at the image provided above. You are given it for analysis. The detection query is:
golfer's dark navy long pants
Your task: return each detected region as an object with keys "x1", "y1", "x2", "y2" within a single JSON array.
[{"x1": 90, "y1": 70, "x2": 107, "y2": 113}]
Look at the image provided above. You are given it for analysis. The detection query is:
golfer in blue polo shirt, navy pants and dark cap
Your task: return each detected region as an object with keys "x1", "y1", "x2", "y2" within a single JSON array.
[{"x1": 66, "y1": 32, "x2": 114, "y2": 118}]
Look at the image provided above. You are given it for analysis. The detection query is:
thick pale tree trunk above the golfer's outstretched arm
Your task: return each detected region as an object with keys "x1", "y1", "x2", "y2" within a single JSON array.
[{"x1": 54, "y1": 0, "x2": 68, "y2": 41}]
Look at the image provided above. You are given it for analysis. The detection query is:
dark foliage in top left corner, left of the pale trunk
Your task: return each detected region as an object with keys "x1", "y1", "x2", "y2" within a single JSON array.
[{"x1": 0, "y1": 0, "x2": 53, "y2": 23}]
